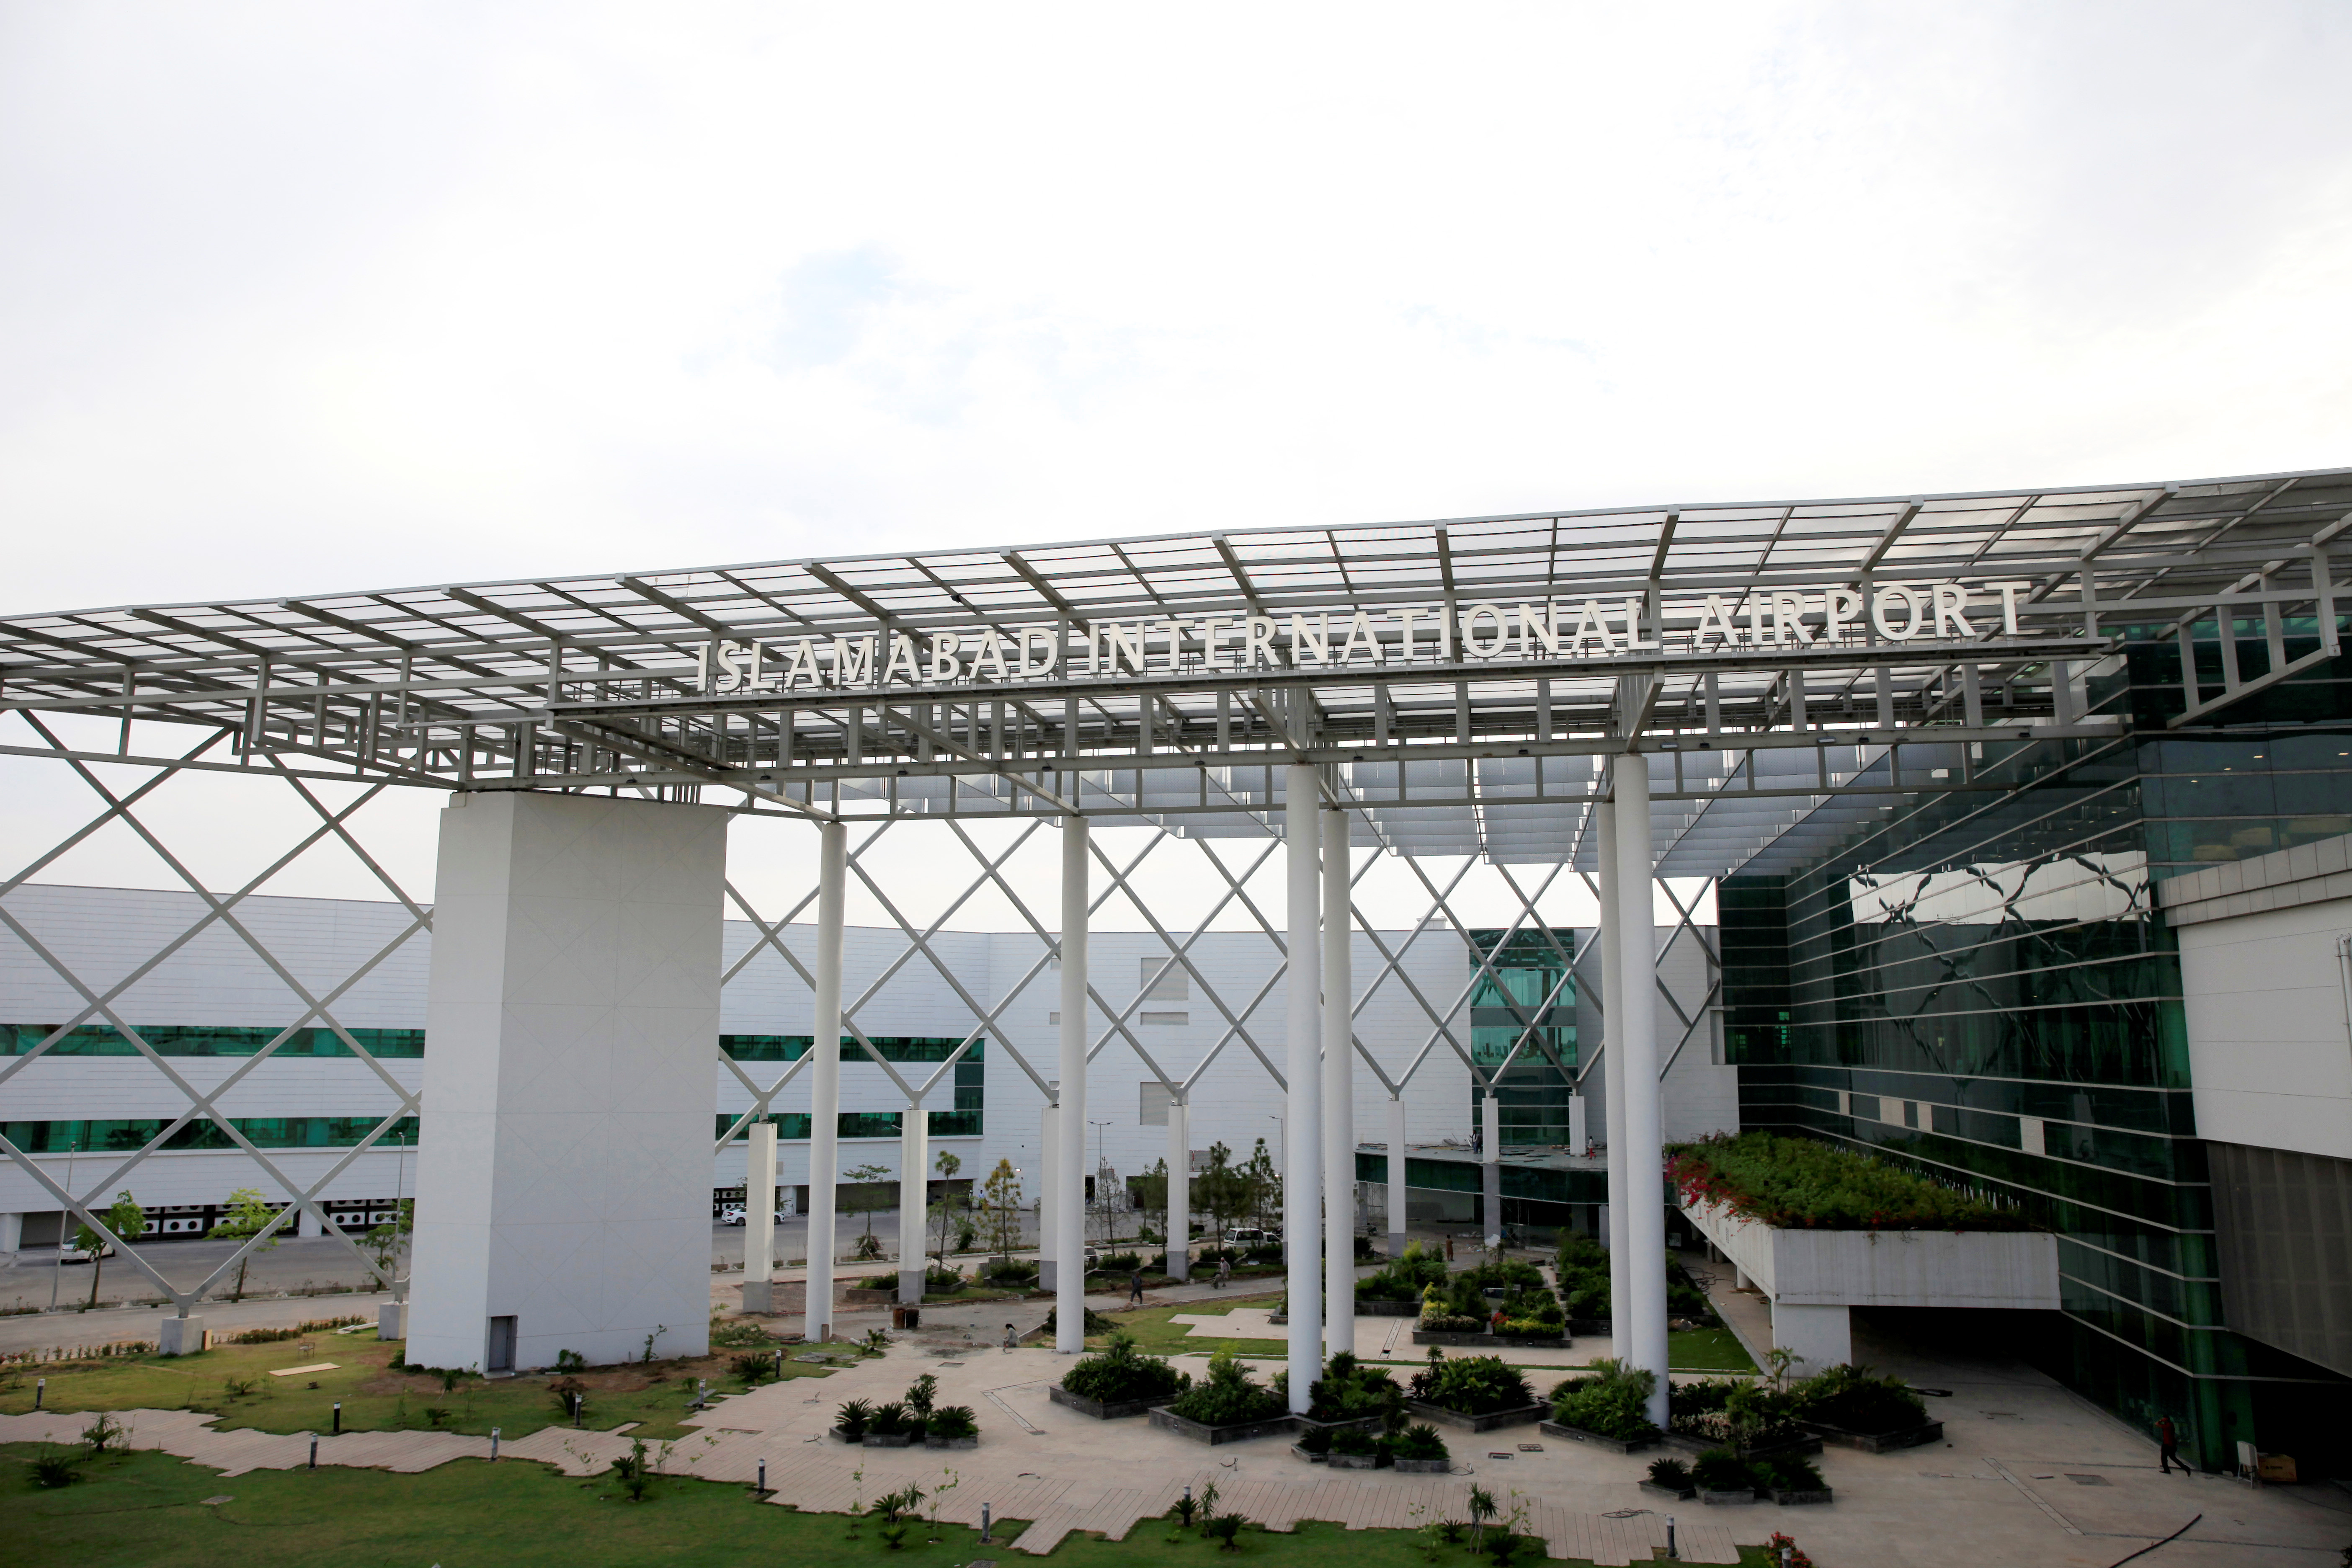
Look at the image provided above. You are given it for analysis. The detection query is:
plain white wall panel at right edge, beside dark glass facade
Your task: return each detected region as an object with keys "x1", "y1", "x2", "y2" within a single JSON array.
[{"x1": 2180, "y1": 900, "x2": 2352, "y2": 1159}]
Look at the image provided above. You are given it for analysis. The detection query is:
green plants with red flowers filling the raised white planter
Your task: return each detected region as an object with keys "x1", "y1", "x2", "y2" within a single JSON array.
[{"x1": 1672, "y1": 1133, "x2": 2037, "y2": 1230}]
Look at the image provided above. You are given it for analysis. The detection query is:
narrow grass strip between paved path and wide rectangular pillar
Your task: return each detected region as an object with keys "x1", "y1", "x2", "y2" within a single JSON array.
[{"x1": 0, "y1": 1328, "x2": 828, "y2": 1439}]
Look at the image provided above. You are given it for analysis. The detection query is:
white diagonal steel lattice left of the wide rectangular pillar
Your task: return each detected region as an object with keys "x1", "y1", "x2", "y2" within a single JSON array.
[{"x1": 0, "y1": 714, "x2": 431, "y2": 1312}]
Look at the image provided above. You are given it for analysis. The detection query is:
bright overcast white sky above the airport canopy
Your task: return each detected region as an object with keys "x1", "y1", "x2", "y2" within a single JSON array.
[{"x1": 0, "y1": 0, "x2": 2352, "y2": 926}]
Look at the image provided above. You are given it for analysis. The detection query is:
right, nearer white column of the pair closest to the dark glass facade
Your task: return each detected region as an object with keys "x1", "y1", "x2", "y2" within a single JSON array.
[{"x1": 1609, "y1": 752, "x2": 1668, "y2": 1427}]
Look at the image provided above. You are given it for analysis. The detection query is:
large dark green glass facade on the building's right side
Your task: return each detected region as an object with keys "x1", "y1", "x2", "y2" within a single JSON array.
[{"x1": 1717, "y1": 623, "x2": 2352, "y2": 1467}]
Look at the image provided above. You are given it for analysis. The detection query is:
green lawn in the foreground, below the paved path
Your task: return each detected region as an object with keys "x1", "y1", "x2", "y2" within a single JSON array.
[{"x1": 0, "y1": 1444, "x2": 1767, "y2": 1568}]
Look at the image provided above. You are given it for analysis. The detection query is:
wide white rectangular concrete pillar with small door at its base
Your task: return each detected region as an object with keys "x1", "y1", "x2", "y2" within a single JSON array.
[{"x1": 409, "y1": 792, "x2": 729, "y2": 1370}]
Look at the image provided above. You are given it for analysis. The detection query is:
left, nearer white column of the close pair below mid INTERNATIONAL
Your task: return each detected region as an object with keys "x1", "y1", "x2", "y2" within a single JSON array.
[{"x1": 1282, "y1": 764, "x2": 1322, "y2": 1415}]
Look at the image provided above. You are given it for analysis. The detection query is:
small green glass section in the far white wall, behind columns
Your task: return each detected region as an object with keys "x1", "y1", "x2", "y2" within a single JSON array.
[{"x1": 1470, "y1": 928, "x2": 1576, "y2": 1147}]
